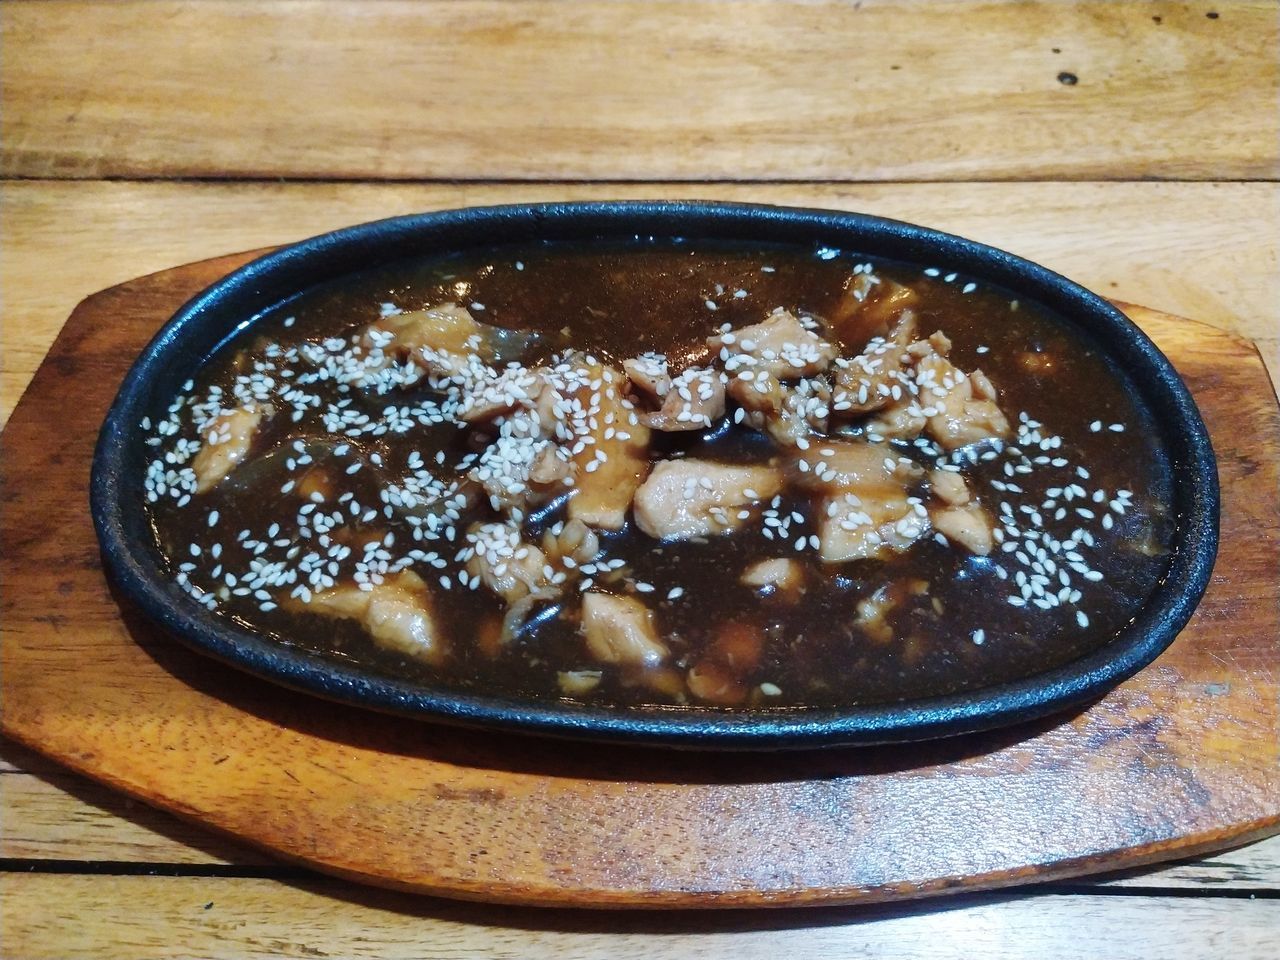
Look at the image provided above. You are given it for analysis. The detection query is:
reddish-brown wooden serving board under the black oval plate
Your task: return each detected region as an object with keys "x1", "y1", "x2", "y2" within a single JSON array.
[{"x1": 0, "y1": 255, "x2": 1280, "y2": 908}]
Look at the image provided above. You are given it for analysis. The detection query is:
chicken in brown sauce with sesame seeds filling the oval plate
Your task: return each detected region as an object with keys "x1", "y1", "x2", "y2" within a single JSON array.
[{"x1": 142, "y1": 238, "x2": 1171, "y2": 708}]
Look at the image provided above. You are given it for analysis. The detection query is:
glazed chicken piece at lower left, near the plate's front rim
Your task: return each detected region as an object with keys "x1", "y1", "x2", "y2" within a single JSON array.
[{"x1": 300, "y1": 570, "x2": 445, "y2": 664}]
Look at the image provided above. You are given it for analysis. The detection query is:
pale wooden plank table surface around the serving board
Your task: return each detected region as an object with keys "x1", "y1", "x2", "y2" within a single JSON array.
[{"x1": 0, "y1": 0, "x2": 1280, "y2": 960}]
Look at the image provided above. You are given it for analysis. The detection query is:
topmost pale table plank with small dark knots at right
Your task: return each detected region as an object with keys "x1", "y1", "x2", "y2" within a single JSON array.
[{"x1": 0, "y1": 0, "x2": 1280, "y2": 180}]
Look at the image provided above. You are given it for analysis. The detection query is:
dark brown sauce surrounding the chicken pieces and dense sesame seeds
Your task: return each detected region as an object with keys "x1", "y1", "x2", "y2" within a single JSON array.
[{"x1": 150, "y1": 241, "x2": 1171, "y2": 707}]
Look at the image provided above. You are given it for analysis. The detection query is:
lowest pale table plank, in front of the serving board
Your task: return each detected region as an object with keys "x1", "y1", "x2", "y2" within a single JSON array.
[{"x1": 0, "y1": 874, "x2": 1280, "y2": 960}]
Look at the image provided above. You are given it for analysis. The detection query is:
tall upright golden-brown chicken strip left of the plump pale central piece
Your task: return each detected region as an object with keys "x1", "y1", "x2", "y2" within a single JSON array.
[{"x1": 568, "y1": 365, "x2": 649, "y2": 530}]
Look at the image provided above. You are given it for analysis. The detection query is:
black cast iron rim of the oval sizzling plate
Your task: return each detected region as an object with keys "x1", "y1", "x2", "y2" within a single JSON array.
[{"x1": 91, "y1": 202, "x2": 1219, "y2": 749}]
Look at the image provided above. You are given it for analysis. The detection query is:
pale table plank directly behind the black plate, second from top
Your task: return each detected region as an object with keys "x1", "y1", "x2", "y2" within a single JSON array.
[{"x1": 0, "y1": 182, "x2": 1280, "y2": 422}]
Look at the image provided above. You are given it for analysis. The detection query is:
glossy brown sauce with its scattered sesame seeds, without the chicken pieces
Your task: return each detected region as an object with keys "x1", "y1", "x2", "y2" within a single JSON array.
[{"x1": 150, "y1": 241, "x2": 1171, "y2": 708}]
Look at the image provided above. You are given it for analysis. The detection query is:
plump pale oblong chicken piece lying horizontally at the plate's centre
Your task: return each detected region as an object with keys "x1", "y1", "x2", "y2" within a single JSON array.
[{"x1": 635, "y1": 458, "x2": 782, "y2": 540}]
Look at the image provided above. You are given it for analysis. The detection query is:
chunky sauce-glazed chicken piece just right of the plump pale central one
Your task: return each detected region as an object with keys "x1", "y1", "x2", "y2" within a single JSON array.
[{"x1": 792, "y1": 440, "x2": 929, "y2": 563}]
